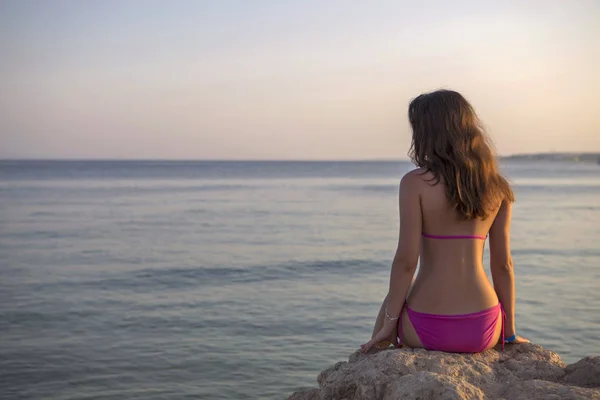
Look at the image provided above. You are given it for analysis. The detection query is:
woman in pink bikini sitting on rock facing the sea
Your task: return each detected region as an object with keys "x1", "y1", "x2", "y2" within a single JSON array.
[{"x1": 361, "y1": 90, "x2": 528, "y2": 353}]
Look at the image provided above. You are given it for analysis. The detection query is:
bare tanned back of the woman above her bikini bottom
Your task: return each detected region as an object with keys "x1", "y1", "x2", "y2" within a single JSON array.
[{"x1": 408, "y1": 170, "x2": 500, "y2": 315}]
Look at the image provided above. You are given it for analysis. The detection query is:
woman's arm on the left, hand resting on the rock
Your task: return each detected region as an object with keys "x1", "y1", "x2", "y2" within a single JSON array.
[{"x1": 361, "y1": 170, "x2": 423, "y2": 353}]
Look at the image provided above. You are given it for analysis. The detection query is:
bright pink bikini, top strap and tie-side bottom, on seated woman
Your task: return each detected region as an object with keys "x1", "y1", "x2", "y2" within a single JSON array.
[{"x1": 398, "y1": 233, "x2": 506, "y2": 353}]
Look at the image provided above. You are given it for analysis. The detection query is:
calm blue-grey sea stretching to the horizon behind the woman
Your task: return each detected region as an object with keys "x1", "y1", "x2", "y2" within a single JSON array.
[{"x1": 0, "y1": 161, "x2": 600, "y2": 399}]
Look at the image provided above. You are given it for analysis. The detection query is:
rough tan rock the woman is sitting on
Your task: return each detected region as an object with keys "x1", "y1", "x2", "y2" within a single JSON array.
[{"x1": 288, "y1": 344, "x2": 600, "y2": 400}]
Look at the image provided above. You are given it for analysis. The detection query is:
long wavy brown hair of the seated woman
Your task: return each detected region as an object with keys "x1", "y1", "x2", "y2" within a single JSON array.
[{"x1": 408, "y1": 90, "x2": 514, "y2": 220}]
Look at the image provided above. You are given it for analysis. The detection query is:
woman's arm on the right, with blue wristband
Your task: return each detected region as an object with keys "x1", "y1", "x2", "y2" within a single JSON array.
[{"x1": 490, "y1": 201, "x2": 528, "y2": 343}]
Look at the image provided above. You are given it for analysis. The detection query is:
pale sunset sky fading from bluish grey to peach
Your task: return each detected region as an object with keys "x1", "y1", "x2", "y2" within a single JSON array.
[{"x1": 0, "y1": 0, "x2": 600, "y2": 160}]
